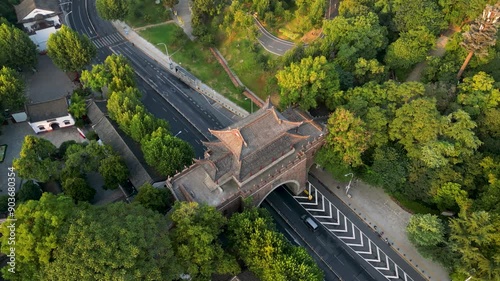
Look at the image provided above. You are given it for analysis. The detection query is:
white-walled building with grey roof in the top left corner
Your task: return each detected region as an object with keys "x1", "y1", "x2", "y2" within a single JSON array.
[{"x1": 14, "y1": 0, "x2": 62, "y2": 52}]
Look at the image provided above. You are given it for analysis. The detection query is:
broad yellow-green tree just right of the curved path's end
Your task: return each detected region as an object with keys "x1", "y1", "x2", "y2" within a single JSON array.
[{"x1": 322, "y1": 12, "x2": 388, "y2": 70}]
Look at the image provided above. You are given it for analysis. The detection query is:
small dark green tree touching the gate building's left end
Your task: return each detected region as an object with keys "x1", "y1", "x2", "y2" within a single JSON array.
[{"x1": 134, "y1": 183, "x2": 174, "y2": 214}]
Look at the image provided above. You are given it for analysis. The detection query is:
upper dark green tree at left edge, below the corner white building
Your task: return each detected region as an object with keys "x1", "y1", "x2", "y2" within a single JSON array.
[{"x1": 0, "y1": 21, "x2": 37, "y2": 68}]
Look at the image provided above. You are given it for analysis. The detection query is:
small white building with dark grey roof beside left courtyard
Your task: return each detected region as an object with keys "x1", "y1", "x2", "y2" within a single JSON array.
[{"x1": 26, "y1": 97, "x2": 75, "y2": 134}]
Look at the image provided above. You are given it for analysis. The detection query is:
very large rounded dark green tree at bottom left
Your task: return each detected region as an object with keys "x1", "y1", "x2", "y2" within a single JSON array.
[{"x1": 44, "y1": 203, "x2": 181, "y2": 281}]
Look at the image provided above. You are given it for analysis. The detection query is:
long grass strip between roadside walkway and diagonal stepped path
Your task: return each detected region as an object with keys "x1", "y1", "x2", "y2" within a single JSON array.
[{"x1": 139, "y1": 23, "x2": 250, "y2": 111}]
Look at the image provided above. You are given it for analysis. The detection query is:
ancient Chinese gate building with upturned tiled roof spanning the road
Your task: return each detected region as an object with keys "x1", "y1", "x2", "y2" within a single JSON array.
[{"x1": 166, "y1": 101, "x2": 324, "y2": 213}]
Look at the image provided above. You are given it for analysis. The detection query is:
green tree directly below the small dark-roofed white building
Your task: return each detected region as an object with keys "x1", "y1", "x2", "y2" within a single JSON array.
[{"x1": 12, "y1": 135, "x2": 59, "y2": 182}]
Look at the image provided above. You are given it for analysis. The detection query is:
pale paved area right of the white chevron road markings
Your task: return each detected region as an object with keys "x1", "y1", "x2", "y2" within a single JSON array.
[{"x1": 310, "y1": 167, "x2": 450, "y2": 281}]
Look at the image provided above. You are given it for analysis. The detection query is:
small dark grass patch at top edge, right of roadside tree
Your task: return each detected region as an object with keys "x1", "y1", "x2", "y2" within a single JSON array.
[{"x1": 125, "y1": 0, "x2": 172, "y2": 28}]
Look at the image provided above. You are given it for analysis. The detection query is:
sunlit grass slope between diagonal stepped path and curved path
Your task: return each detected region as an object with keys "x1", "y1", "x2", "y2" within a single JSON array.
[{"x1": 218, "y1": 30, "x2": 279, "y2": 105}]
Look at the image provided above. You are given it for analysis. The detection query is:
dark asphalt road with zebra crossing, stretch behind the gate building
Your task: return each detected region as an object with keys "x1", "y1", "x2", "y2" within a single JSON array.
[{"x1": 67, "y1": 0, "x2": 238, "y2": 157}]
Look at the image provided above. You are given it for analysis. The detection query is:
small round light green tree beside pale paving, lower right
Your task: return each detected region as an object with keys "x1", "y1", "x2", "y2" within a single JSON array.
[{"x1": 406, "y1": 214, "x2": 444, "y2": 246}]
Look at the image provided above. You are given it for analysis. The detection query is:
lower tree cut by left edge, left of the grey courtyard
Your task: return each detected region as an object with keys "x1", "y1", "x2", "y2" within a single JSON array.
[{"x1": 0, "y1": 66, "x2": 26, "y2": 111}]
